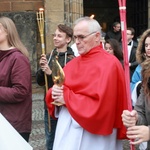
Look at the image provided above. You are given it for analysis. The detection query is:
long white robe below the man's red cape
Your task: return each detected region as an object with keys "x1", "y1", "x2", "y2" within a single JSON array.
[{"x1": 53, "y1": 106, "x2": 123, "y2": 150}]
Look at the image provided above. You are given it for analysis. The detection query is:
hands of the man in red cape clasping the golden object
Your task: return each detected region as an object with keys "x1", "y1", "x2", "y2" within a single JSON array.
[{"x1": 52, "y1": 85, "x2": 65, "y2": 104}]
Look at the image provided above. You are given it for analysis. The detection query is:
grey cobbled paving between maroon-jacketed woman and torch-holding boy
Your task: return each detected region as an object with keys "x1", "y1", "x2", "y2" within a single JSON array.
[{"x1": 29, "y1": 93, "x2": 46, "y2": 150}]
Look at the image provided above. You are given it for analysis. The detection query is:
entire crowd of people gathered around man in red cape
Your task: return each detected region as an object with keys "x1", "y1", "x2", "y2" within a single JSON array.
[{"x1": 0, "y1": 14, "x2": 150, "y2": 150}]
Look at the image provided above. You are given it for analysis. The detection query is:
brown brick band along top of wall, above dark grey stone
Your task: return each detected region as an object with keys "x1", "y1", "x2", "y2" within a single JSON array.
[{"x1": 0, "y1": 0, "x2": 44, "y2": 12}]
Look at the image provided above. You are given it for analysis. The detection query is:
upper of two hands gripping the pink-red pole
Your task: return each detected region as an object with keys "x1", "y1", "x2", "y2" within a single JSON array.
[{"x1": 122, "y1": 110, "x2": 138, "y2": 127}]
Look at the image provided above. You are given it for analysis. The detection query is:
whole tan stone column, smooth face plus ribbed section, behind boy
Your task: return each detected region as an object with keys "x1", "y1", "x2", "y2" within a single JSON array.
[{"x1": 44, "y1": 0, "x2": 83, "y2": 53}]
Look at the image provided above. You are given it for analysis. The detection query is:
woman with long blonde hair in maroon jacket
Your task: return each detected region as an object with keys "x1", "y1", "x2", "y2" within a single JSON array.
[{"x1": 0, "y1": 17, "x2": 32, "y2": 141}]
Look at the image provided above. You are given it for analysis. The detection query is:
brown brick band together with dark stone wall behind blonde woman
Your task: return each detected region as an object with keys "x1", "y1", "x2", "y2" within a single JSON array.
[{"x1": 0, "y1": 0, "x2": 44, "y2": 76}]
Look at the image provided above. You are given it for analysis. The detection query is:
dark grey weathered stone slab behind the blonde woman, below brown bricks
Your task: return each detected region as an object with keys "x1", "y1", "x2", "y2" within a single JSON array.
[{"x1": 0, "y1": 12, "x2": 38, "y2": 76}]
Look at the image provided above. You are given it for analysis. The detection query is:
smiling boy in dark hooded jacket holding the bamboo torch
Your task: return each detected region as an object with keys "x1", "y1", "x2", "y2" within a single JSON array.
[{"x1": 36, "y1": 24, "x2": 75, "y2": 150}]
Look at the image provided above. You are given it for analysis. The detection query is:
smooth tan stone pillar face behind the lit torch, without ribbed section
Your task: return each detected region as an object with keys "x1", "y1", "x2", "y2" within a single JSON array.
[{"x1": 44, "y1": 0, "x2": 64, "y2": 53}]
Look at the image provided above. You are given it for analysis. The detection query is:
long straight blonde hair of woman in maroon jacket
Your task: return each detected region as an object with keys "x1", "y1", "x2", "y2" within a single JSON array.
[{"x1": 0, "y1": 16, "x2": 29, "y2": 58}]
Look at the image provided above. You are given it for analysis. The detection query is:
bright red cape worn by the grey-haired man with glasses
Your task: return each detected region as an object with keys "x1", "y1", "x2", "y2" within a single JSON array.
[{"x1": 46, "y1": 46, "x2": 127, "y2": 139}]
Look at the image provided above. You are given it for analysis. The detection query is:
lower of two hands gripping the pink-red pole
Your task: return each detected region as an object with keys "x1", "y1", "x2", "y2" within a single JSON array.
[{"x1": 127, "y1": 125, "x2": 150, "y2": 145}]
